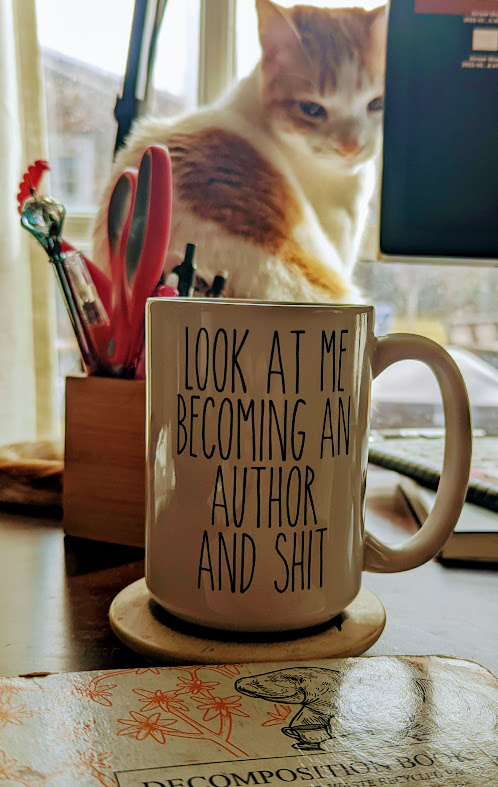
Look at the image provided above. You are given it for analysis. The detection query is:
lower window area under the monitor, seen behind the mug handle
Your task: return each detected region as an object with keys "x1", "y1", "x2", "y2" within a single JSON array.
[{"x1": 356, "y1": 261, "x2": 498, "y2": 435}]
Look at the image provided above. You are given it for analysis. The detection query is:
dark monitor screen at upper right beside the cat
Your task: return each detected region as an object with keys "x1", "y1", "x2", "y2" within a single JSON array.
[{"x1": 380, "y1": 0, "x2": 498, "y2": 261}]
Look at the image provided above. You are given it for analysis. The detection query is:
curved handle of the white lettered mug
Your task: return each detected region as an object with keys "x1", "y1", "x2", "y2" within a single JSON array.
[{"x1": 364, "y1": 333, "x2": 472, "y2": 573}]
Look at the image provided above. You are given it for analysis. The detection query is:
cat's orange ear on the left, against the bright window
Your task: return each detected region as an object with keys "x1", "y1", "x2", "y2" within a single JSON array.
[{"x1": 256, "y1": 0, "x2": 312, "y2": 97}]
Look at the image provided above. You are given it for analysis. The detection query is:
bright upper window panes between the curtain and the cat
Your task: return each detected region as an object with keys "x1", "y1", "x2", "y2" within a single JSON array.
[{"x1": 37, "y1": 0, "x2": 199, "y2": 219}]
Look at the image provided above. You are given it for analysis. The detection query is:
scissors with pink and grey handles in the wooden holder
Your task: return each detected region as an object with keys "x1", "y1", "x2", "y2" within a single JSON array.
[{"x1": 107, "y1": 145, "x2": 172, "y2": 376}]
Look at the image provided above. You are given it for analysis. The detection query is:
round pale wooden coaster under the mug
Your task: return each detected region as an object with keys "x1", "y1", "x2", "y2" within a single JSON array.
[{"x1": 109, "y1": 579, "x2": 386, "y2": 664}]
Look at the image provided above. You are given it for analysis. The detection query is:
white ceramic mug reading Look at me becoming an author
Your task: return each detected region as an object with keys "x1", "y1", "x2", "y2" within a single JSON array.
[{"x1": 146, "y1": 298, "x2": 471, "y2": 632}]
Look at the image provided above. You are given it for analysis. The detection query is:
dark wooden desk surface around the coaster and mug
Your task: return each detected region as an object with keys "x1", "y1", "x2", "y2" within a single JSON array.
[{"x1": 0, "y1": 467, "x2": 498, "y2": 676}]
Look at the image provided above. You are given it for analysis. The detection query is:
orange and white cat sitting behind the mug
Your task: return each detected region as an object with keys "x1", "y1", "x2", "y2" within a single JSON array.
[{"x1": 94, "y1": 0, "x2": 386, "y2": 303}]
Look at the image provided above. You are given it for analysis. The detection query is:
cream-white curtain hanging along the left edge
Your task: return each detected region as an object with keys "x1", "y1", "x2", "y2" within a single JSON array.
[{"x1": 0, "y1": 0, "x2": 60, "y2": 445}]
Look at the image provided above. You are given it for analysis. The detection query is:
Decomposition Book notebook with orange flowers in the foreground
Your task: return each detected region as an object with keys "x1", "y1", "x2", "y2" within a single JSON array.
[{"x1": 0, "y1": 656, "x2": 498, "y2": 787}]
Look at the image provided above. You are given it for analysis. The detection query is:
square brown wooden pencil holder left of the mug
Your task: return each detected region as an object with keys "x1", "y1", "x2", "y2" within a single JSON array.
[{"x1": 63, "y1": 376, "x2": 145, "y2": 547}]
